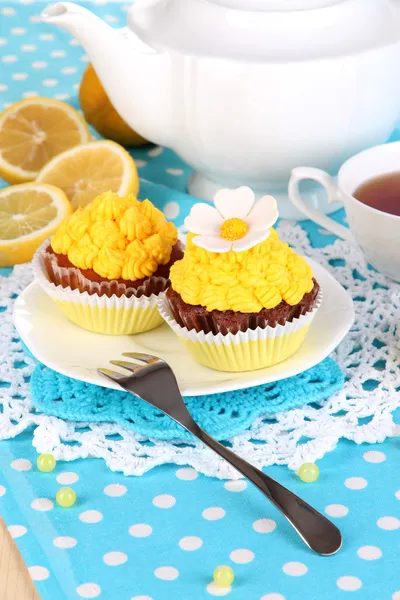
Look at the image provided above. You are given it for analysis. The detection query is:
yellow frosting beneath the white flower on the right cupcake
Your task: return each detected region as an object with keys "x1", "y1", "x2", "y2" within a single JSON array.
[{"x1": 170, "y1": 228, "x2": 314, "y2": 313}]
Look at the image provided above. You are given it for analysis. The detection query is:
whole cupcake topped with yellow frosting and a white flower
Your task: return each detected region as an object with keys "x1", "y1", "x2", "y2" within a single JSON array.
[{"x1": 159, "y1": 187, "x2": 322, "y2": 371}]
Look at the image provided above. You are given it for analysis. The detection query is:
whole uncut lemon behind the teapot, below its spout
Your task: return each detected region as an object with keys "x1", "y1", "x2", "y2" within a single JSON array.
[{"x1": 79, "y1": 65, "x2": 147, "y2": 147}]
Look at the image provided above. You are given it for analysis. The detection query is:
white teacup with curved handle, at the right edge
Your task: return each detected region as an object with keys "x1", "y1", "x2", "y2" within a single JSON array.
[{"x1": 289, "y1": 142, "x2": 400, "y2": 281}]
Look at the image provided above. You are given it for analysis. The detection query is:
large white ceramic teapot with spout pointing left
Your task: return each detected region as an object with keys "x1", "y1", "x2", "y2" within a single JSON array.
[{"x1": 42, "y1": 0, "x2": 400, "y2": 218}]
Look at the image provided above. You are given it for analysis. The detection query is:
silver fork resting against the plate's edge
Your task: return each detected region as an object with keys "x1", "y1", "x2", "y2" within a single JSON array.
[{"x1": 98, "y1": 352, "x2": 342, "y2": 556}]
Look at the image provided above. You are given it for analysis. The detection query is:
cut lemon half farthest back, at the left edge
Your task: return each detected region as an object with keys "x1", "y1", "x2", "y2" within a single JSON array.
[{"x1": 0, "y1": 98, "x2": 91, "y2": 183}]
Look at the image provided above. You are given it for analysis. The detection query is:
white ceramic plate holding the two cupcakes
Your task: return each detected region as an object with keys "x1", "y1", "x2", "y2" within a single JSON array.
[{"x1": 14, "y1": 259, "x2": 354, "y2": 396}]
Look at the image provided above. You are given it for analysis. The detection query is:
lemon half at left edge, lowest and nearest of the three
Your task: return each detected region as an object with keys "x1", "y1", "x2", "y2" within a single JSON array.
[{"x1": 0, "y1": 183, "x2": 72, "y2": 267}]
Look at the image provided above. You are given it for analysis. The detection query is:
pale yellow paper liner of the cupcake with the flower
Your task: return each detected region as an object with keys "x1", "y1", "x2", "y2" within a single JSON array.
[{"x1": 158, "y1": 290, "x2": 322, "y2": 372}]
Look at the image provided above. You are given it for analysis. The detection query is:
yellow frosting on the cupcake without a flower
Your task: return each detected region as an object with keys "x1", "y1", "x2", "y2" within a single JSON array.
[{"x1": 51, "y1": 192, "x2": 178, "y2": 281}]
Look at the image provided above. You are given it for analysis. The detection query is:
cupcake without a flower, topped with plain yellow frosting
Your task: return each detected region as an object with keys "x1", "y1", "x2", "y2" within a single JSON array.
[{"x1": 34, "y1": 192, "x2": 183, "y2": 335}]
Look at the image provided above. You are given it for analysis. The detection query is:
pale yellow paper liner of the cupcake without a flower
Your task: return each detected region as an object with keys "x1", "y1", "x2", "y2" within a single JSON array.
[{"x1": 33, "y1": 242, "x2": 163, "y2": 335}]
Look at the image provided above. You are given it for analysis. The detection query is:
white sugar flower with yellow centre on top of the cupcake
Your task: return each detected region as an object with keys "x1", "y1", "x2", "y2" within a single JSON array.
[{"x1": 185, "y1": 187, "x2": 279, "y2": 253}]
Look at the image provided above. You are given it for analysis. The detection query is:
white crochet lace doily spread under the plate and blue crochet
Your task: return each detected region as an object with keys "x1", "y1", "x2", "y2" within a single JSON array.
[{"x1": 0, "y1": 222, "x2": 400, "y2": 479}]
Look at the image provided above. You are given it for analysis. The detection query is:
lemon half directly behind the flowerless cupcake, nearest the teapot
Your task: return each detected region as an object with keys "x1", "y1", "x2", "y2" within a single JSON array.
[{"x1": 37, "y1": 140, "x2": 139, "y2": 210}]
